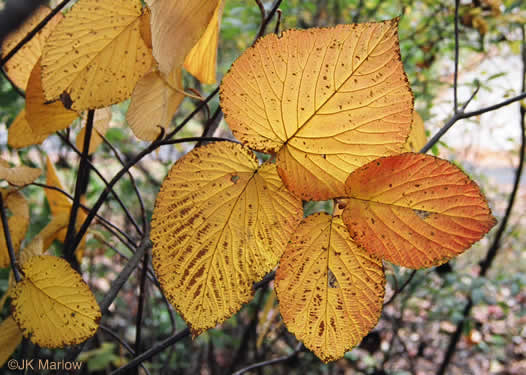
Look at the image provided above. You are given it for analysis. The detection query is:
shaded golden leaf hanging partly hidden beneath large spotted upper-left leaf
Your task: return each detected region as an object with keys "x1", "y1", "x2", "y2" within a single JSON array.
[{"x1": 26, "y1": 60, "x2": 79, "y2": 137}]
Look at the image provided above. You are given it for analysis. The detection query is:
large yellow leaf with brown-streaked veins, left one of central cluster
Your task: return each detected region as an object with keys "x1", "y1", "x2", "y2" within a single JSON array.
[{"x1": 150, "y1": 142, "x2": 302, "y2": 336}]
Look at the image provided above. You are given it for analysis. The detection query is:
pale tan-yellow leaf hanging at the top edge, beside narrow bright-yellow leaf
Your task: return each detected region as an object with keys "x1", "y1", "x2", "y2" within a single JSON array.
[{"x1": 146, "y1": 0, "x2": 220, "y2": 74}]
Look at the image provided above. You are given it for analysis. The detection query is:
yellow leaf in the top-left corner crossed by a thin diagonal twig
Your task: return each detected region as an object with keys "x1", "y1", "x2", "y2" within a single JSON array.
[{"x1": 2, "y1": 6, "x2": 63, "y2": 90}]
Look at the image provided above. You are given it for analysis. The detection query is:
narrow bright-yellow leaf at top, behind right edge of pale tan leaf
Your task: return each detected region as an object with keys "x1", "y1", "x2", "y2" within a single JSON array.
[{"x1": 184, "y1": 0, "x2": 225, "y2": 84}]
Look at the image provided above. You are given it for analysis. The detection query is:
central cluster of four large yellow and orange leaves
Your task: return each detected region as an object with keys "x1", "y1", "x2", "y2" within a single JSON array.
[{"x1": 151, "y1": 15, "x2": 495, "y2": 361}]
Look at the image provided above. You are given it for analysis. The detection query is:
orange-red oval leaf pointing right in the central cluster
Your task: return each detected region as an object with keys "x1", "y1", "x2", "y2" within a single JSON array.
[{"x1": 343, "y1": 153, "x2": 496, "y2": 269}]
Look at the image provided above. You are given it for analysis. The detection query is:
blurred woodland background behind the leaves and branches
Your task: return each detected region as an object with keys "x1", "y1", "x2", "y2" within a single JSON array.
[{"x1": 0, "y1": 0, "x2": 526, "y2": 375}]
